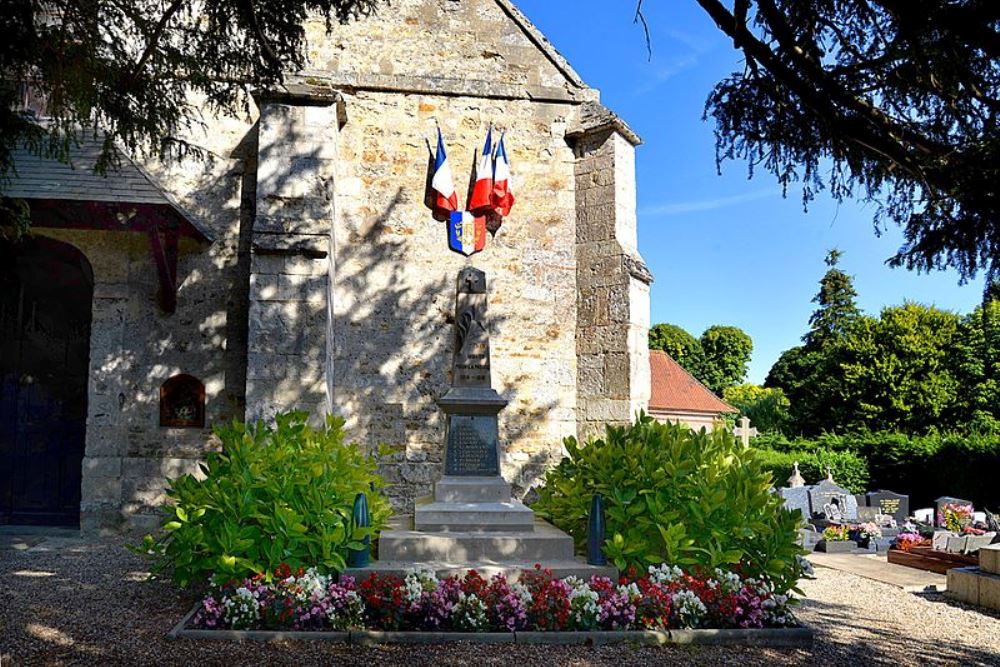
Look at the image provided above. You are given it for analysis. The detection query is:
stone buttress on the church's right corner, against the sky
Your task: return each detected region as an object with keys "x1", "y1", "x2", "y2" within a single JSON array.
[{"x1": 571, "y1": 112, "x2": 652, "y2": 439}]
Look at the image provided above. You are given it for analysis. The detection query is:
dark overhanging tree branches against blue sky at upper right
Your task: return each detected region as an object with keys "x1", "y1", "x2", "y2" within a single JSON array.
[{"x1": 697, "y1": 0, "x2": 1000, "y2": 279}]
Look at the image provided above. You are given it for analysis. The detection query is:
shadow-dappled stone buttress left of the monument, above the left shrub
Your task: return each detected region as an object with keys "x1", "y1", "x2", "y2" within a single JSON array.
[{"x1": 247, "y1": 101, "x2": 339, "y2": 419}]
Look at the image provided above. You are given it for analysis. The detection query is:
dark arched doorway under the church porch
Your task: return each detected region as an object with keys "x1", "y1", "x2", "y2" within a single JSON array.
[{"x1": 0, "y1": 237, "x2": 94, "y2": 526}]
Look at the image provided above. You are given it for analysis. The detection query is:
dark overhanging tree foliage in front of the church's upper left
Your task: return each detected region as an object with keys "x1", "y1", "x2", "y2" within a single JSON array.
[{"x1": 0, "y1": 0, "x2": 382, "y2": 190}]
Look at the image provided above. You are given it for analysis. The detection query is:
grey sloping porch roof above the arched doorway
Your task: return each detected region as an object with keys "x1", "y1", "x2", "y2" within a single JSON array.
[{"x1": 0, "y1": 133, "x2": 212, "y2": 241}]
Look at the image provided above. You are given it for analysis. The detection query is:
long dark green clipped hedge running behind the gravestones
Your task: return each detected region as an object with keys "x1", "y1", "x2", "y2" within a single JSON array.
[{"x1": 753, "y1": 432, "x2": 1000, "y2": 510}]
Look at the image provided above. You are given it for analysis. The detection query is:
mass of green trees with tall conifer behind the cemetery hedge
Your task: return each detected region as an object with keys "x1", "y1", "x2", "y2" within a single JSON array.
[{"x1": 765, "y1": 250, "x2": 1000, "y2": 435}]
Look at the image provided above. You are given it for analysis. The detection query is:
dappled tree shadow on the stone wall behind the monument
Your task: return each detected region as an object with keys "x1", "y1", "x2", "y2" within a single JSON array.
[{"x1": 332, "y1": 188, "x2": 558, "y2": 513}]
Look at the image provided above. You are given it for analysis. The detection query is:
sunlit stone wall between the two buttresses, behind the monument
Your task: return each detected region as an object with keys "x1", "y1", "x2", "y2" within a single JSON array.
[{"x1": 332, "y1": 92, "x2": 577, "y2": 512}]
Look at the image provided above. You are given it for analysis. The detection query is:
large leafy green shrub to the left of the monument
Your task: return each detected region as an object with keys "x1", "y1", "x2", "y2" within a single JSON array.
[{"x1": 135, "y1": 412, "x2": 391, "y2": 587}]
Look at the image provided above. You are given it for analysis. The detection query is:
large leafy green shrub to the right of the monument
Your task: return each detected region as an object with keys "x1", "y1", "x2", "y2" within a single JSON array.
[{"x1": 534, "y1": 415, "x2": 803, "y2": 591}]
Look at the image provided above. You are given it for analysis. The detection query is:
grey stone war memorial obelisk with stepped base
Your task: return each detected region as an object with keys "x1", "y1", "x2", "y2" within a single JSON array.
[{"x1": 346, "y1": 269, "x2": 618, "y2": 579}]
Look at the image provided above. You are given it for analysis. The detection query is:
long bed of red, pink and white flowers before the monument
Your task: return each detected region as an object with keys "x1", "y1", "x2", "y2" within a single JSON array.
[{"x1": 192, "y1": 565, "x2": 797, "y2": 632}]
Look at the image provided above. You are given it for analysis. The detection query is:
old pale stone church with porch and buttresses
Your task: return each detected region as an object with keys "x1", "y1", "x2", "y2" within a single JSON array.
[{"x1": 0, "y1": 0, "x2": 652, "y2": 529}]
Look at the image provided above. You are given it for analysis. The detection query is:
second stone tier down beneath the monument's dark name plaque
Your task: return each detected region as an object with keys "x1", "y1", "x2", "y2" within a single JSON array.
[{"x1": 413, "y1": 499, "x2": 535, "y2": 533}]
